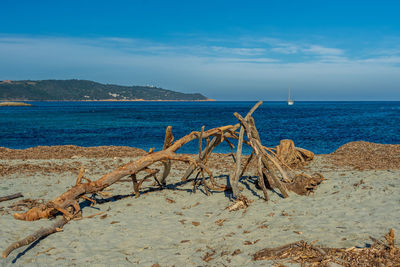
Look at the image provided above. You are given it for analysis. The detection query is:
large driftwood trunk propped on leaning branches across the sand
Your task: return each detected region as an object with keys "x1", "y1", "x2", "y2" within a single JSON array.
[{"x1": 3, "y1": 101, "x2": 322, "y2": 257}]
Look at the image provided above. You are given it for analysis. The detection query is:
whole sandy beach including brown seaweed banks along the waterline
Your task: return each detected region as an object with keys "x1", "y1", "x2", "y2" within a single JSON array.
[{"x1": 0, "y1": 142, "x2": 400, "y2": 266}]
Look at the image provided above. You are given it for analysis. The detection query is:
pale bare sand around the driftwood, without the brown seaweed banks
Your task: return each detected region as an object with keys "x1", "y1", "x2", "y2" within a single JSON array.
[{"x1": 0, "y1": 158, "x2": 400, "y2": 266}]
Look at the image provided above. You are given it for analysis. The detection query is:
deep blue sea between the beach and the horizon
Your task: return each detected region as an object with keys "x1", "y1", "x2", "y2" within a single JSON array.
[{"x1": 0, "y1": 102, "x2": 400, "y2": 154}]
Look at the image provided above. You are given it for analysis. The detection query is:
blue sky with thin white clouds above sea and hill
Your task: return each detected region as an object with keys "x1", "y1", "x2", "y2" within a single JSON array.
[{"x1": 0, "y1": 0, "x2": 400, "y2": 101}]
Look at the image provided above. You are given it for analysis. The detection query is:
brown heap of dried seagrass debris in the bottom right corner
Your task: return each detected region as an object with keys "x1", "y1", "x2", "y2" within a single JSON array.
[{"x1": 253, "y1": 229, "x2": 400, "y2": 266}]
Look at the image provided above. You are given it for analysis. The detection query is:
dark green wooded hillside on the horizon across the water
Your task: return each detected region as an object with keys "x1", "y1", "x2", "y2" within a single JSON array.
[{"x1": 0, "y1": 80, "x2": 207, "y2": 100}]
